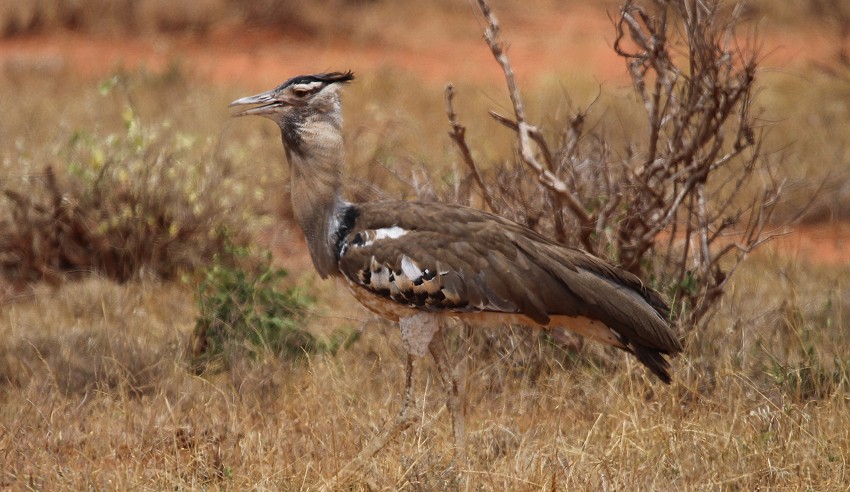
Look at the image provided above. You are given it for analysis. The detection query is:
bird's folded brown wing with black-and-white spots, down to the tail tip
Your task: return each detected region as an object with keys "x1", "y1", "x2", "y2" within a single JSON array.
[{"x1": 340, "y1": 202, "x2": 681, "y2": 382}]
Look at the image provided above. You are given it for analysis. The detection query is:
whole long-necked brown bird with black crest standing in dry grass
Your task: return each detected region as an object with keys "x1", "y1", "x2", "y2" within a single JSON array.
[{"x1": 231, "y1": 71, "x2": 682, "y2": 459}]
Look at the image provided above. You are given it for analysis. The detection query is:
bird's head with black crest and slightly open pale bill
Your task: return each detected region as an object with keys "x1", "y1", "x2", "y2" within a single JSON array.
[{"x1": 230, "y1": 70, "x2": 354, "y2": 127}]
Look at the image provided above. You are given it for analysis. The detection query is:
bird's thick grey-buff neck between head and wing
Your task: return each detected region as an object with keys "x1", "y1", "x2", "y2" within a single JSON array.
[{"x1": 282, "y1": 113, "x2": 348, "y2": 278}]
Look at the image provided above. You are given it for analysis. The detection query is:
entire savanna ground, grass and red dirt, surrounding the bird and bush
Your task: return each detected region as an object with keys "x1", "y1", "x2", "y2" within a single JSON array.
[{"x1": 0, "y1": 0, "x2": 850, "y2": 490}]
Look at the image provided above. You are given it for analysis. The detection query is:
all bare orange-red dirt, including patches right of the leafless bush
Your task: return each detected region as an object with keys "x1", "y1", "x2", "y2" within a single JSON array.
[{"x1": 0, "y1": 8, "x2": 850, "y2": 265}]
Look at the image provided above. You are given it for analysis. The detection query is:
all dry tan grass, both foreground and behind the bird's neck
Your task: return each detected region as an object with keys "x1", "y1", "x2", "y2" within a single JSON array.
[{"x1": 0, "y1": 2, "x2": 850, "y2": 490}]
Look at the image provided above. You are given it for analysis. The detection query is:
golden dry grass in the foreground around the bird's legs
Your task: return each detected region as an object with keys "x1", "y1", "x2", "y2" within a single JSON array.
[{"x1": 0, "y1": 257, "x2": 850, "y2": 490}]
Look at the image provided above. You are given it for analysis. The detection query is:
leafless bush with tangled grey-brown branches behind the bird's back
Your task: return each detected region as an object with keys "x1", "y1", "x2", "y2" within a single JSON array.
[{"x1": 447, "y1": 0, "x2": 781, "y2": 326}]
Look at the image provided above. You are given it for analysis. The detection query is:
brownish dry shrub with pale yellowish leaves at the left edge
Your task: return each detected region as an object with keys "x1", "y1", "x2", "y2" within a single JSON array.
[{"x1": 0, "y1": 75, "x2": 246, "y2": 286}]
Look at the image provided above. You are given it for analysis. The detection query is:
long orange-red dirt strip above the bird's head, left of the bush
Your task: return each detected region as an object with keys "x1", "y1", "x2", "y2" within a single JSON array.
[{"x1": 0, "y1": 7, "x2": 624, "y2": 86}]
